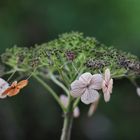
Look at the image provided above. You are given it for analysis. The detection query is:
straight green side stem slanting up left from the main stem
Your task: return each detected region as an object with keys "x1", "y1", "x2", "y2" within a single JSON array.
[{"x1": 33, "y1": 75, "x2": 65, "y2": 112}]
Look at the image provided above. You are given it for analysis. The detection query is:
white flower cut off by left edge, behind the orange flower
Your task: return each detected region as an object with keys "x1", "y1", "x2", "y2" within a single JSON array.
[{"x1": 0, "y1": 78, "x2": 9, "y2": 99}]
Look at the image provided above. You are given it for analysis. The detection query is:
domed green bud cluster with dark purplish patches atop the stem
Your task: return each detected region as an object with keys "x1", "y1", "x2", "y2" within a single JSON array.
[{"x1": 1, "y1": 32, "x2": 140, "y2": 77}]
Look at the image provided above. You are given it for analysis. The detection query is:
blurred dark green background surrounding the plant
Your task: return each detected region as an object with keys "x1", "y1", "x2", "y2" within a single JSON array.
[{"x1": 0, "y1": 0, "x2": 140, "y2": 140}]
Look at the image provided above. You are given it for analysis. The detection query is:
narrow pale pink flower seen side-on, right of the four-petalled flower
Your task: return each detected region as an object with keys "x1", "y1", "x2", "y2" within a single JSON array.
[{"x1": 102, "y1": 69, "x2": 113, "y2": 102}]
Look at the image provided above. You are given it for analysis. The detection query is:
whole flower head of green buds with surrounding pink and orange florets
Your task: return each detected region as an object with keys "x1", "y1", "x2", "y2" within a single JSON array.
[{"x1": 0, "y1": 32, "x2": 140, "y2": 116}]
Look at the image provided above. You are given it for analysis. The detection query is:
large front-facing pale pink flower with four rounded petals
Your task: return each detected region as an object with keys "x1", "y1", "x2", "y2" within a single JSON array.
[{"x1": 71, "y1": 72, "x2": 102, "y2": 104}]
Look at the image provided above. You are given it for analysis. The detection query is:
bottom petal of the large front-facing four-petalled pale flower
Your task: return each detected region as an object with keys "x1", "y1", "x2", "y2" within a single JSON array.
[{"x1": 81, "y1": 89, "x2": 99, "y2": 104}]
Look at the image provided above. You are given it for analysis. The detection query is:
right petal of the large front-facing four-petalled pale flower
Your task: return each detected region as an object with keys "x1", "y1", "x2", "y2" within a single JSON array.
[{"x1": 91, "y1": 74, "x2": 103, "y2": 90}]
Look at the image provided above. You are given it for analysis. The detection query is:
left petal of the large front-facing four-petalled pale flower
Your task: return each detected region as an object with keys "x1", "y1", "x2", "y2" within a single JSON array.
[{"x1": 71, "y1": 80, "x2": 86, "y2": 97}]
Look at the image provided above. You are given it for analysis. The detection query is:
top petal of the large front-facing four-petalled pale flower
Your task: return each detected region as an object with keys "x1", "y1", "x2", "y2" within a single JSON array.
[{"x1": 79, "y1": 72, "x2": 92, "y2": 85}]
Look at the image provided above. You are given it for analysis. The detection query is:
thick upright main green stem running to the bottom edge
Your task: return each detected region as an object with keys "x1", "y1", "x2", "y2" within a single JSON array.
[{"x1": 61, "y1": 97, "x2": 73, "y2": 140}]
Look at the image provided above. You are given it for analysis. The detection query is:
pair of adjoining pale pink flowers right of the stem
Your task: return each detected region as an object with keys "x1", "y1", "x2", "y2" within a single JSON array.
[{"x1": 71, "y1": 69, "x2": 113, "y2": 104}]
